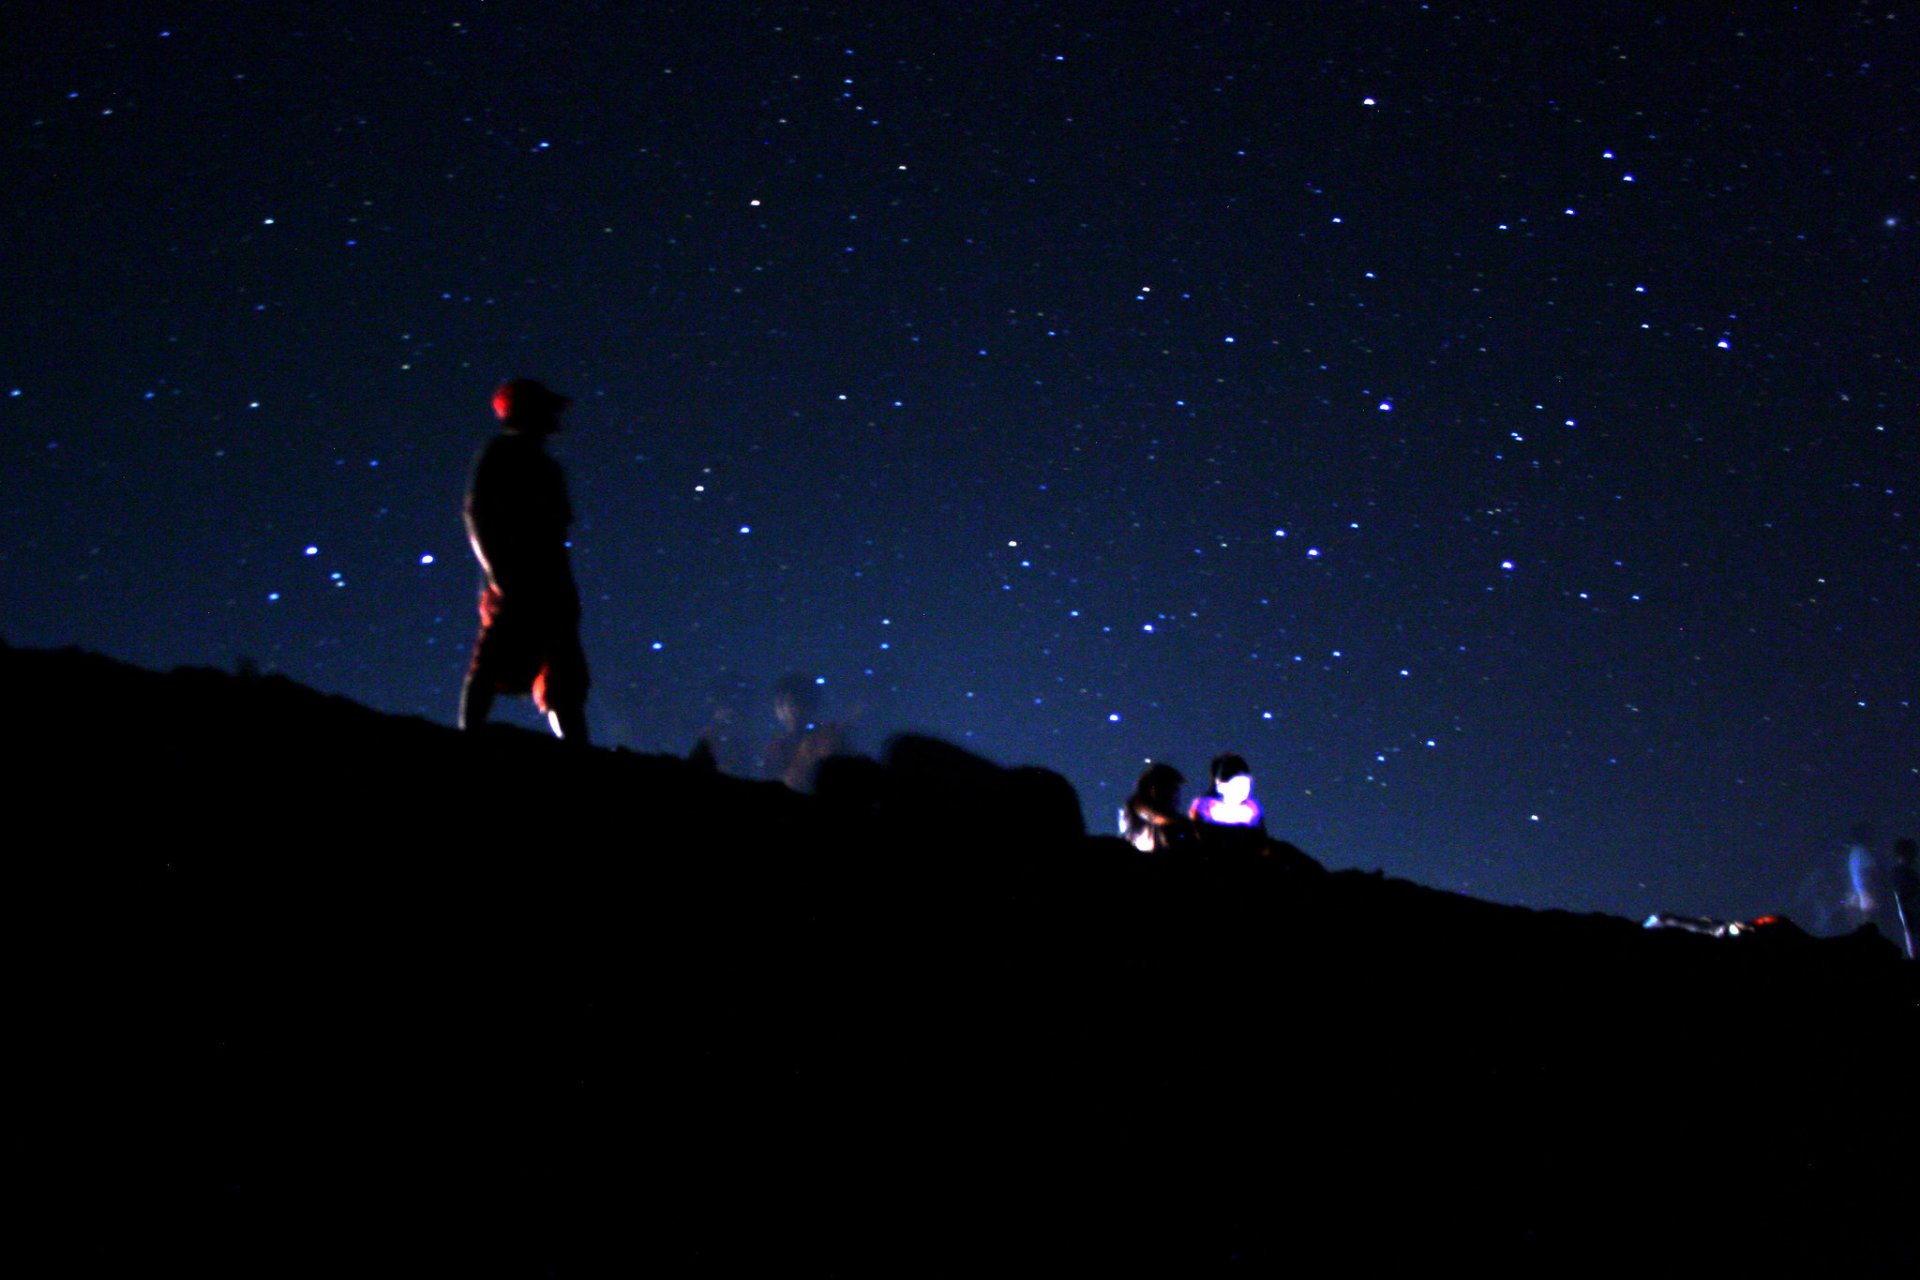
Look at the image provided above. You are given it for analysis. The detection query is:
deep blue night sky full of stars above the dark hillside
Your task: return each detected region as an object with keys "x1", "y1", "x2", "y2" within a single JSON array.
[{"x1": 0, "y1": 0, "x2": 1920, "y2": 923}]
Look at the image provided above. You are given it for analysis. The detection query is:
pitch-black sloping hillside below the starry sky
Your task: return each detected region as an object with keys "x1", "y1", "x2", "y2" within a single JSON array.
[{"x1": 11, "y1": 651, "x2": 1920, "y2": 1274}]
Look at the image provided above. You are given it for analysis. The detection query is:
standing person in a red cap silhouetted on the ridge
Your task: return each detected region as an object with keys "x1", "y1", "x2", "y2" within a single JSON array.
[{"x1": 461, "y1": 378, "x2": 588, "y2": 745}]
